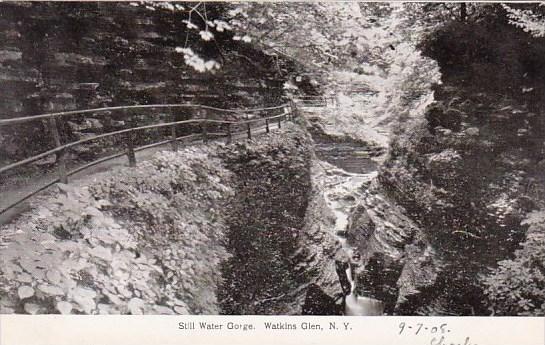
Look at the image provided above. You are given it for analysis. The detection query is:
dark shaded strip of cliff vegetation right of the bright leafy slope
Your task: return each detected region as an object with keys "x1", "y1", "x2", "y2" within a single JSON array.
[{"x1": 219, "y1": 124, "x2": 312, "y2": 315}]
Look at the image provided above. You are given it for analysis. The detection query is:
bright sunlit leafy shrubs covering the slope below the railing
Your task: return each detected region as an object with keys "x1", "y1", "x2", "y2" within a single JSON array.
[{"x1": 0, "y1": 147, "x2": 231, "y2": 314}]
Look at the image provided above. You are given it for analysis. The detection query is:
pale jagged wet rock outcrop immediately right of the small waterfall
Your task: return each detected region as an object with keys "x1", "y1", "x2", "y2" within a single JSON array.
[{"x1": 347, "y1": 180, "x2": 441, "y2": 315}]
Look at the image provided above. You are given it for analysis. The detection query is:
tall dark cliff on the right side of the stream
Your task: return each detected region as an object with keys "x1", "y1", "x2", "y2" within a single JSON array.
[{"x1": 349, "y1": 14, "x2": 545, "y2": 315}]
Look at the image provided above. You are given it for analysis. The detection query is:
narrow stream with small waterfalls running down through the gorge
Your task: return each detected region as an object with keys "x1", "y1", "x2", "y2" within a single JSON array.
[{"x1": 304, "y1": 121, "x2": 383, "y2": 315}]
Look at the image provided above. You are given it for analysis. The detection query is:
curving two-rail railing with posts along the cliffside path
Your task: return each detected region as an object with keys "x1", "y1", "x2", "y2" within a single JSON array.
[{"x1": 0, "y1": 101, "x2": 297, "y2": 215}]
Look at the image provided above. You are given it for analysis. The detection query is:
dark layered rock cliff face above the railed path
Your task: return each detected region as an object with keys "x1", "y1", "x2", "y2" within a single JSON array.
[{"x1": 0, "y1": 2, "x2": 286, "y2": 160}]
